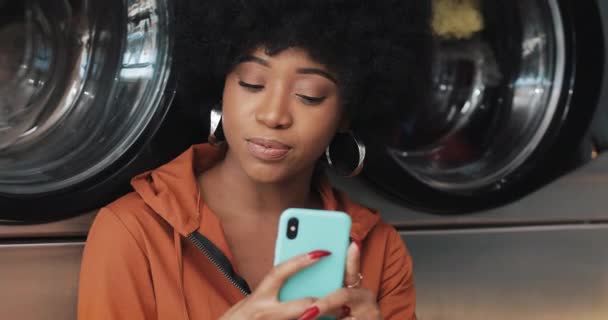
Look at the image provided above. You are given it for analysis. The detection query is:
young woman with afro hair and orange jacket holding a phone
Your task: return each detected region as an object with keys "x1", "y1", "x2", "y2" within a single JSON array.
[{"x1": 78, "y1": 0, "x2": 430, "y2": 320}]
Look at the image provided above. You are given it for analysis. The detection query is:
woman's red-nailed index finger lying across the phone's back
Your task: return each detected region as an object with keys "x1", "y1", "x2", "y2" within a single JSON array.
[{"x1": 256, "y1": 250, "x2": 331, "y2": 295}]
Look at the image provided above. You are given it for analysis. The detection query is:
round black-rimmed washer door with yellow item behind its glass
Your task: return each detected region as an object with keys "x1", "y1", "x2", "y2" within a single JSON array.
[{"x1": 365, "y1": 0, "x2": 604, "y2": 213}]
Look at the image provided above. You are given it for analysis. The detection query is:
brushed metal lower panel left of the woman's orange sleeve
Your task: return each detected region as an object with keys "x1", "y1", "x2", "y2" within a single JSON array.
[{"x1": 0, "y1": 242, "x2": 84, "y2": 320}]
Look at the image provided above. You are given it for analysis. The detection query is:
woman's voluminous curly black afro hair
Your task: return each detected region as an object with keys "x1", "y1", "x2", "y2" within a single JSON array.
[{"x1": 175, "y1": 0, "x2": 432, "y2": 142}]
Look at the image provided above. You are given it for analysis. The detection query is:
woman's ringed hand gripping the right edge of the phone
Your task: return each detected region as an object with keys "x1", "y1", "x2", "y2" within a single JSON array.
[{"x1": 306, "y1": 241, "x2": 382, "y2": 320}]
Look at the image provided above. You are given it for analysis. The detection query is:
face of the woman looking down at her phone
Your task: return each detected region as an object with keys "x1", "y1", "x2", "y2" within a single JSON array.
[{"x1": 222, "y1": 48, "x2": 344, "y2": 183}]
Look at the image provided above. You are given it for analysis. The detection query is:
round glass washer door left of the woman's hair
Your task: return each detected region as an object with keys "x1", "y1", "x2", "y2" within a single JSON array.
[{"x1": 0, "y1": 0, "x2": 197, "y2": 221}]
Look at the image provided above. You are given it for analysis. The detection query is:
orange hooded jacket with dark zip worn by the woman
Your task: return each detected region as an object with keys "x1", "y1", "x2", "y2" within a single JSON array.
[{"x1": 78, "y1": 145, "x2": 415, "y2": 320}]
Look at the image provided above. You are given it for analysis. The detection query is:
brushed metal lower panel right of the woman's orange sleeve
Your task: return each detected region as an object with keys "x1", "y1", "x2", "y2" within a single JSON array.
[{"x1": 402, "y1": 225, "x2": 608, "y2": 320}]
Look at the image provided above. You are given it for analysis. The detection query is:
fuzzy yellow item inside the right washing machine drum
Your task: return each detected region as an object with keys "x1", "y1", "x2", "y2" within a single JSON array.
[{"x1": 432, "y1": 0, "x2": 484, "y2": 39}]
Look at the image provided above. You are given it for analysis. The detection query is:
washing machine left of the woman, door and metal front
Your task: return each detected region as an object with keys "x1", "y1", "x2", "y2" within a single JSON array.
[{"x1": 0, "y1": 0, "x2": 206, "y2": 319}]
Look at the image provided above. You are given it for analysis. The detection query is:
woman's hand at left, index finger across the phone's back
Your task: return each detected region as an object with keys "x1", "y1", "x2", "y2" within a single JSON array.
[{"x1": 220, "y1": 250, "x2": 330, "y2": 320}]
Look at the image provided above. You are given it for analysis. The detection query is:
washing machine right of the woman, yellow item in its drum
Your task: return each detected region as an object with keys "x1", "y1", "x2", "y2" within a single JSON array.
[{"x1": 334, "y1": 0, "x2": 608, "y2": 320}]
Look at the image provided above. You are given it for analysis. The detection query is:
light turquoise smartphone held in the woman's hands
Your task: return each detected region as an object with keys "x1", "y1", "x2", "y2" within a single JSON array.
[{"x1": 274, "y1": 208, "x2": 351, "y2": 301}]
